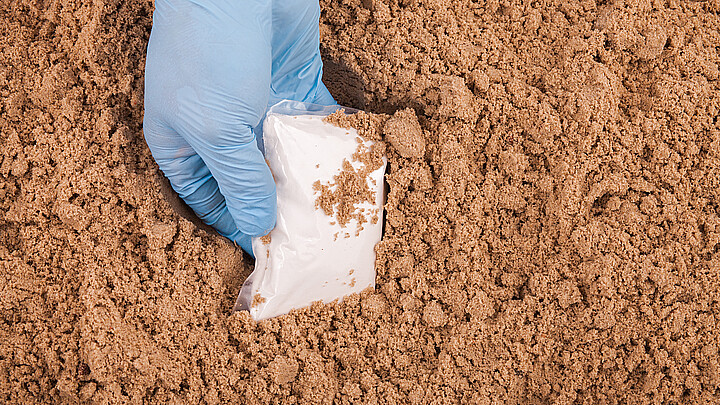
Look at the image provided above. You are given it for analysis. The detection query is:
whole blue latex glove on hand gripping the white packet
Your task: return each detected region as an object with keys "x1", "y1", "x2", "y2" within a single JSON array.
[{"x1": 144, "y1": 0, "x2": 335, "y2": 254}]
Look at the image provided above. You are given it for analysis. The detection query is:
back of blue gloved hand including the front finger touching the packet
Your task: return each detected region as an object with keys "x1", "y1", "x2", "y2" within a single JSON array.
[{"x1": 146, "y1": 0, "x2": 277, "y2": 237}]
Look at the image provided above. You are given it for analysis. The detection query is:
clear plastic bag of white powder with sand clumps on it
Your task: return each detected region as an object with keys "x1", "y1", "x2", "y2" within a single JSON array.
[{"x1": 235, "y1": 101, "x2": 386, "y2": 320}]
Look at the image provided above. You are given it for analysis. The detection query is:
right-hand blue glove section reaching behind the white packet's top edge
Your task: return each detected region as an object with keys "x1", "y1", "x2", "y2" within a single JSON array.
[{"x1": 270, "y1": 0, "x2": 335, "y2": 105}]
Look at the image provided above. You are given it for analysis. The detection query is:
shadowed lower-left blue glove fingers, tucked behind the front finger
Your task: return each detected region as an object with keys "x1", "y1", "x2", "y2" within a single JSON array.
[{"x1": 144, "y1": 120, "x2": 252, "y2": 255}]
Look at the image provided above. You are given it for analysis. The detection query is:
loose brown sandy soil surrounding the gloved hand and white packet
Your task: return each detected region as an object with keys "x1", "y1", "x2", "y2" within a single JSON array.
[{"x1": 0, "y1": 0, "x2": 720, "y2": 404}]
